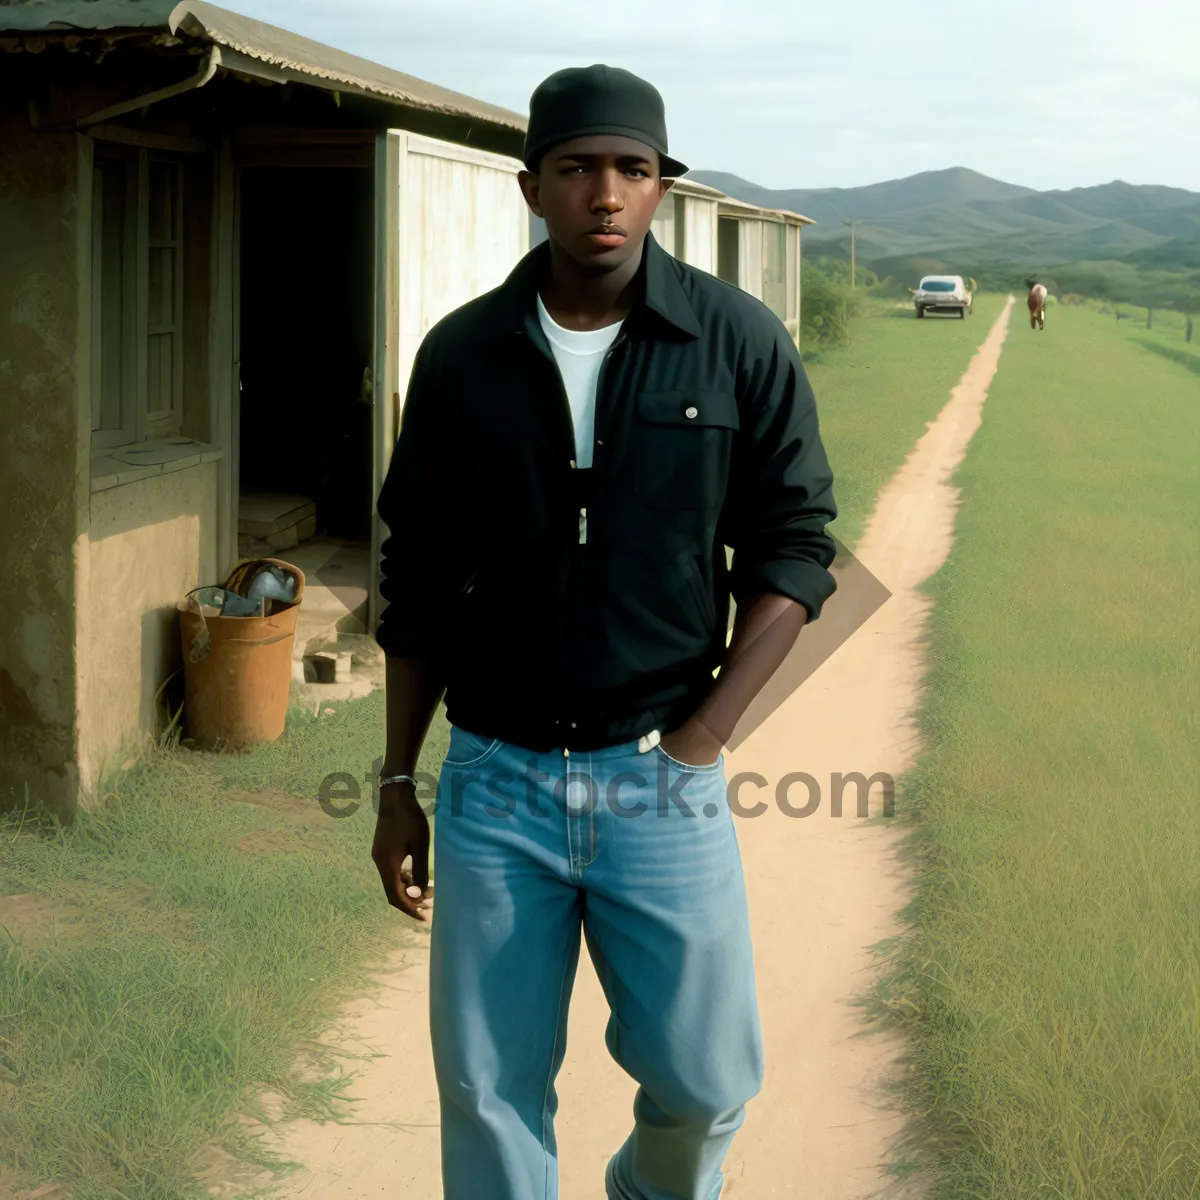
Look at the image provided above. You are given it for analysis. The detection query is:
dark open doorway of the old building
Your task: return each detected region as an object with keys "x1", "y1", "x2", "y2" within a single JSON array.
[{"x1": 239, "y1": 167, "x2": 374, "y2": 556}]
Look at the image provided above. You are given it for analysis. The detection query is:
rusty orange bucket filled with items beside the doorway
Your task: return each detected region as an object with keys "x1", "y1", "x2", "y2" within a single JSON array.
[{"x1": 178, "y1": 558, "x2": 304, "y2": 750}]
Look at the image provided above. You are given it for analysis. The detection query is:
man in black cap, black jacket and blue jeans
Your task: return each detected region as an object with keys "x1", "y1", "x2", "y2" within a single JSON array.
[{"x1": 372, "y1": 66, "x2": 836, "y2": 1200}]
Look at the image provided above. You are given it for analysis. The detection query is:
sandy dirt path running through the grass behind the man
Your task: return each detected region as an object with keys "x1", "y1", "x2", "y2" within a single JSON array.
[{"x1": 234, "y1": 296, "x2": 1013, "y2": 1200}]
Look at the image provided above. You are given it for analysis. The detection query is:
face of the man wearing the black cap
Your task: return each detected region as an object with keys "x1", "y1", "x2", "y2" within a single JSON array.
[{"x1": 520, "y1": 134, "x2": 671, "y2": 271}]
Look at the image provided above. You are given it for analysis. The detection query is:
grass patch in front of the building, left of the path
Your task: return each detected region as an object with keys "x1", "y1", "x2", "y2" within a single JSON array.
[{"x1": 0, "y1": 692, "x2": 448, "y2": 1200}]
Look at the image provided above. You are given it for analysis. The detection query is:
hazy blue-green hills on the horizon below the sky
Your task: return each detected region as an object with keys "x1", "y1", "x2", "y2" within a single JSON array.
[{"x1": 688, "y1": 167, "x2": 1200, "y2": 283}]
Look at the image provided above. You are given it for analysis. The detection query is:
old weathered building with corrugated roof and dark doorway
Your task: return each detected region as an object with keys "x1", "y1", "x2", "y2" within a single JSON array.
[{"x1": 0, "y1": 0, "x2": 804, "y2": 814}]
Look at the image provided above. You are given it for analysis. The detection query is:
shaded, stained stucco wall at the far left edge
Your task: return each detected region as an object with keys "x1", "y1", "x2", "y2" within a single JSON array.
[{"x1": 0, "y1": 103, "x2": 86, "y2": 815}]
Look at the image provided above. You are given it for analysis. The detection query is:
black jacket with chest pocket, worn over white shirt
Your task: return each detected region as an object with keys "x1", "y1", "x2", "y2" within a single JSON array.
[{"x1": 376, "y1": 235, "x2": 838, "y2": 750}]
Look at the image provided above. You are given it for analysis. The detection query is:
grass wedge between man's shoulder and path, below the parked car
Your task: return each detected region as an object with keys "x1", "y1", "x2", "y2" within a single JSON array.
[{"x1": 804, "y1": 295, "x2": 1004, "y2": 547}]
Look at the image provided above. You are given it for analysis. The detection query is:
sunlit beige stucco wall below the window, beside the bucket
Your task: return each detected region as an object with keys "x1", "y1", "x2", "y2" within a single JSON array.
[{"x1": 79, "y1": 462, "x2": 218, "y2": 790}]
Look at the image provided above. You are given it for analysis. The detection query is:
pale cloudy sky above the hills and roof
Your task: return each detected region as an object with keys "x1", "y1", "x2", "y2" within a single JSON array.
[{"x1": 217, "y1": 0, "x2": 1200, "y2": 192}]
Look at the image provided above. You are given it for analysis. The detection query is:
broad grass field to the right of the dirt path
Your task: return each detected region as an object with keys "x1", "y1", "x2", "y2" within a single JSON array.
[{"x1": 877, "y1": 300, "x2": 1200, "y2": 1200}]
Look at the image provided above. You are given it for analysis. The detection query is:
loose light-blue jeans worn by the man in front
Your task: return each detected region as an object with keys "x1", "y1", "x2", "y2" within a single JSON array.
[{"x1": 430, "y1": 728, "x2": 762, "y2": 1200}]
